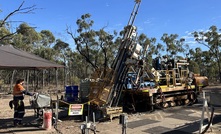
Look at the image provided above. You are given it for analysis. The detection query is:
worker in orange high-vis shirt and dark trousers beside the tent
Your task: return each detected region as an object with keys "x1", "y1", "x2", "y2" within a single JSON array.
[{"x1": 13, "y1": 79, "x2": 34, "y2": 126}]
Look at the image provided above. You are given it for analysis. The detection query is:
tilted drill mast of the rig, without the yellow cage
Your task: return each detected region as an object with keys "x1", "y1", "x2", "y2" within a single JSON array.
[{"x1": 107, "y1": 0, "x2": 141, "y2": 106}]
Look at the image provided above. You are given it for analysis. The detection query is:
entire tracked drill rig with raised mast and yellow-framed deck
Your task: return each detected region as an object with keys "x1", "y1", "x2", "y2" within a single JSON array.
[{"x1": 81, "y1": 0, "x2": 208, "y2": 118}]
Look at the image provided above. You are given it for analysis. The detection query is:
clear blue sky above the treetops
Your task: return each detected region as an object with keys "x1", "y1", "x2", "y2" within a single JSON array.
[{"x1": 0, "y1": 0, "x2": 221, "y2": 47}]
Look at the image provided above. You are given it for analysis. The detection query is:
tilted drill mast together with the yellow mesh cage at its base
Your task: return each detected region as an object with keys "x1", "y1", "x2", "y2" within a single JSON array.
[{"x1": 84, "y1": 0, "x2": 147, "y2": 119}]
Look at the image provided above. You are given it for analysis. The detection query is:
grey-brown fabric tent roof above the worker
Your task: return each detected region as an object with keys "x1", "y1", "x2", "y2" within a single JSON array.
[{"x1": 0, "y1": 45, "x2": 64, "y2": 69}]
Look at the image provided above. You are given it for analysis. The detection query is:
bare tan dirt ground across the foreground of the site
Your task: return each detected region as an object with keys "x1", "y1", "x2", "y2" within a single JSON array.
[{"x1": 0, "y1": 86, "x2": 221, "y2": 134}]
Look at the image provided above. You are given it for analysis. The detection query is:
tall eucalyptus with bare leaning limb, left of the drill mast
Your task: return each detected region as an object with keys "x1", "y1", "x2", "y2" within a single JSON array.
[{"x1": 67, "y1": 14, "x2": 98, "y2": 75}]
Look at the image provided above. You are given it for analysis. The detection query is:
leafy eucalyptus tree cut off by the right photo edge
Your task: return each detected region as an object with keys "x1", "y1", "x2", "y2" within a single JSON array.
[{"x1": 193, "y1": 26, "x2": 221, "y2": 82}]
